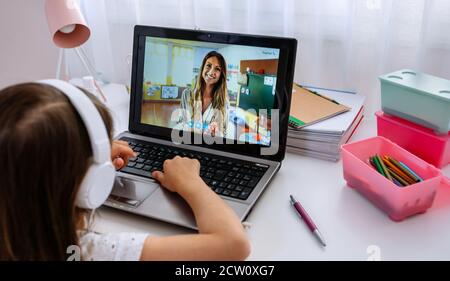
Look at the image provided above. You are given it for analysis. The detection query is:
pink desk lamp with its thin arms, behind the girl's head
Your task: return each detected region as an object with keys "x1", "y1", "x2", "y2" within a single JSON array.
[{"x1": 45, "y1": 0, "x2": 106, "y2": 101}]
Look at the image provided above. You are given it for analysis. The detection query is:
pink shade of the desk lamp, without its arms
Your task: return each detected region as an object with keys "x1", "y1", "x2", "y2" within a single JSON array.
[{"x1": 45, "y1": 0, "x2": 91, "y2": 48}]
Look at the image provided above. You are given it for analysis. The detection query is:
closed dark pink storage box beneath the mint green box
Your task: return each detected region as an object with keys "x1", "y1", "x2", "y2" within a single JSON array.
[{"x1": 375, "y1": 111, "x2": 450, "y2": 168}]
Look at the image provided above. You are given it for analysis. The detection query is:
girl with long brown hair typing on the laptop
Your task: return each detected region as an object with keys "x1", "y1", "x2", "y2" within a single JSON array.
[{"x1": 0, "y1": 83, "x2": 249, "y2": 260}]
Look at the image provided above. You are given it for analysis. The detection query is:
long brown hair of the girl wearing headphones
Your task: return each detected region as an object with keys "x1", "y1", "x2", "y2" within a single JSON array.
[{"x1": 0, "y1": 83, "x2": 112, "y2": 260}]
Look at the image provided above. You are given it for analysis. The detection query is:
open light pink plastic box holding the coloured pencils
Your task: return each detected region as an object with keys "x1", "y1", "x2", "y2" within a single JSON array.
[{"x1": 342, "y1": 137, "x2": 450, "y2": 221}]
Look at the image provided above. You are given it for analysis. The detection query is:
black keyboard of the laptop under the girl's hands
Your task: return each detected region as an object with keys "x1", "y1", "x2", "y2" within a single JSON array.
[{"x1": 120, "y1": 138, "x2": 269, "y2": 200}]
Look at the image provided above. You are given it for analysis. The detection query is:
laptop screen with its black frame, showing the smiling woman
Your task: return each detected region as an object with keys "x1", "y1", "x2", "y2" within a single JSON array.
[{"x1": 130, "y1": 26, "x2": 296, "y2": 161}]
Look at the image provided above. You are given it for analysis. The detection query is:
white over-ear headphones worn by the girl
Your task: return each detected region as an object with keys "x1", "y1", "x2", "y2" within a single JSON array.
[{"x1": 38, "y1": 79, "x2": 116, "y2": 209}]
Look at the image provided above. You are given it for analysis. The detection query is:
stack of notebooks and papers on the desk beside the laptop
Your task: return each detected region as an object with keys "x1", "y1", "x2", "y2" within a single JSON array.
[{"x1": 287, "y1": 85, "x2": 364, "y2": 161}]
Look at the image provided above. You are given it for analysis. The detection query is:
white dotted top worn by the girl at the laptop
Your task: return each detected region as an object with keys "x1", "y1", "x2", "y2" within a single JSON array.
[{"x1": 79, "y1": 232, "x2": 148, "y2": 261}]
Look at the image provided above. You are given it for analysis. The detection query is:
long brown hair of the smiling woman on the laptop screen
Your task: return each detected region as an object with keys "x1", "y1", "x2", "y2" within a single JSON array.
[{"x1": 189, "y1": 51, "x2": 228, "y2": 122}]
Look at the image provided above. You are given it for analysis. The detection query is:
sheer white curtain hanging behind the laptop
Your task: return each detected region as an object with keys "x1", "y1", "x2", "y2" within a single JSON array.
[{"x1": 71, "y1": 0, "x2": 450, "y2": 116}]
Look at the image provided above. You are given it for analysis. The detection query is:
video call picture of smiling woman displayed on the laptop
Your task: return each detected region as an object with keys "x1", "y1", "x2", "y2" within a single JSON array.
[{"x1": 141, "y1": 37, "x2": 280, "y2": 145}]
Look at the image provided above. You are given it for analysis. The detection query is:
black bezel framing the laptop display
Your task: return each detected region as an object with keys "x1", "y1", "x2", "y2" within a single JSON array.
[{"x1": 128, "y1": 25, "x2": 297, "y2": 162}]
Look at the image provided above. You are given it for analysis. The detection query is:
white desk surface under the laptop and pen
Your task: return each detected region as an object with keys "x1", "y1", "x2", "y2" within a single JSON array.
[{"x1": 95, "y1": 85, "x2": 450, "y2": 260}]
